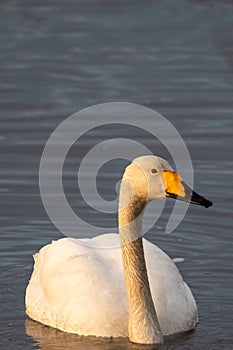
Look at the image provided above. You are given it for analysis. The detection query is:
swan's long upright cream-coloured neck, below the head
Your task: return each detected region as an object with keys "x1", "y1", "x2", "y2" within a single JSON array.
[{"x1": 119, "y1": 182, "x2": 163, "y2": 344}]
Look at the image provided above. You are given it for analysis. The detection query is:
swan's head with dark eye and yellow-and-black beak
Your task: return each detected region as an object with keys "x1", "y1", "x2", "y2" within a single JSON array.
[{"x1": 123, "y1": 156, "x2": 212, "y2": 208}]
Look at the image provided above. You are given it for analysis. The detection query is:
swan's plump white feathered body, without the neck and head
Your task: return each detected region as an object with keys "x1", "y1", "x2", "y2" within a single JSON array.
[{"x1": 26, "y1": 234, "x2": 197, "y2": 337}]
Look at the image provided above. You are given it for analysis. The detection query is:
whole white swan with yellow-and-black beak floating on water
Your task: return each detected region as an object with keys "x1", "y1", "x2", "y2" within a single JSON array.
[{"x1": 25, "y1": 156, "x2": 212, "y2": 344}]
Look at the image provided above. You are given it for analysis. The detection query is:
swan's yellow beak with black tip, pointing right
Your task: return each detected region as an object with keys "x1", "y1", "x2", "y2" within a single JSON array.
[{"x1": 162, "y1": 171, "x2": 213, "y2": 208}]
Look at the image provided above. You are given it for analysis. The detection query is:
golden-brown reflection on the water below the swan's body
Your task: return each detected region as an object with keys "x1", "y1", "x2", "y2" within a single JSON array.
[{"x1": 25, "y1": 318, "x2": 162, "y2": 350}]
